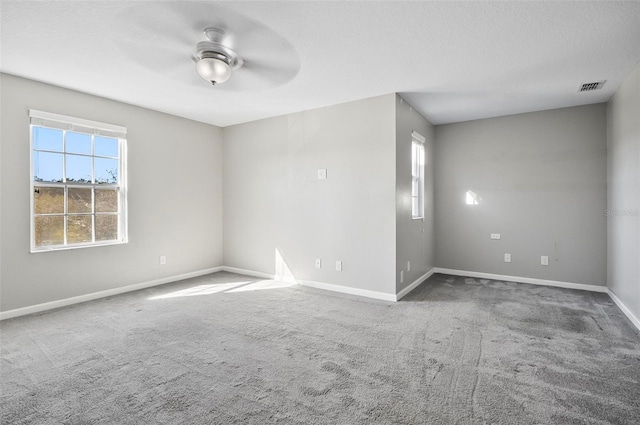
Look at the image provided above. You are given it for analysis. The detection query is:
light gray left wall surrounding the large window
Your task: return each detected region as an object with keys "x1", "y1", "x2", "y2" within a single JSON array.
[{"x1": 0, "y1": 74, "x2": 222, "y2": 311}]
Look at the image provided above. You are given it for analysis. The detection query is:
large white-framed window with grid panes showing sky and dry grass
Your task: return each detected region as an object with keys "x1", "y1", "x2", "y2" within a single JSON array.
[{"x1": 29, "y1": 110, "x2": 127, "y2": 252}]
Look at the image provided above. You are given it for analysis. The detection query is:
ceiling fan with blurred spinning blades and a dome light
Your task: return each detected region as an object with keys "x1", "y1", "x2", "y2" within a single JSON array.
[{"x1": 115, "y1": 1, "x2": 300, "y2": 92}]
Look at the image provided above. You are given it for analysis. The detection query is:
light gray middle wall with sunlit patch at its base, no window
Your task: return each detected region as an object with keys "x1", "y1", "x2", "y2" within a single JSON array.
[{"x1": 223, "y1": 94, "x2": 396, "y2": 294}]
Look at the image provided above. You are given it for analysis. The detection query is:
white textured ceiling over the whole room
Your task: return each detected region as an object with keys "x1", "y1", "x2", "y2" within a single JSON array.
[{"x1": 0, "y1": 0, "x2": 640, "y2": 126}]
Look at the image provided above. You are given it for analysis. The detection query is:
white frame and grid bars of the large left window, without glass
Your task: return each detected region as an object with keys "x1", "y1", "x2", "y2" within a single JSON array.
[{"x1": 29, "y1": 109, "x2": 128, "y2": 253}]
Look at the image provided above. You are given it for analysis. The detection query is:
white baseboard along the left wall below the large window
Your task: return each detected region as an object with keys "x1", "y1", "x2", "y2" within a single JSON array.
[{"x1": 0, "y1": 267, "x2": 222, "y2": 320}]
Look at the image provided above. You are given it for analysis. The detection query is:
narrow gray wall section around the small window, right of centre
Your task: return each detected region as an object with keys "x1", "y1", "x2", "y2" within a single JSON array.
[{"x1": 396, "y1": 96, "x2": 435, "y2": 292}]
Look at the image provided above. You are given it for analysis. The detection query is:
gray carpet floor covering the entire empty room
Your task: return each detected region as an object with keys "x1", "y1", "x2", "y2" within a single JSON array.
[{"x1": 0, "y1": 273, "x2": 640, "y2": 425}]
